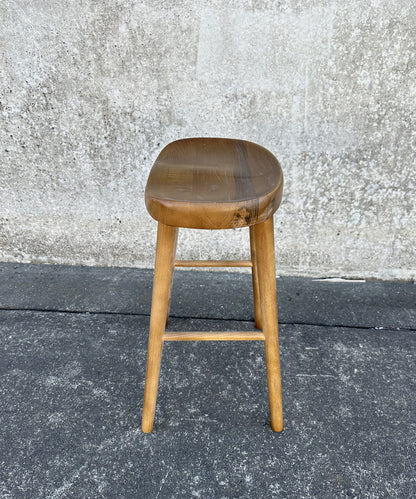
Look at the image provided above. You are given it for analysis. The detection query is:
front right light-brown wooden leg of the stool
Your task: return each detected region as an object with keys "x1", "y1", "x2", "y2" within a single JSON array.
[{"x1": 254, "y1": 217, "x2": 283, "y2": 431}]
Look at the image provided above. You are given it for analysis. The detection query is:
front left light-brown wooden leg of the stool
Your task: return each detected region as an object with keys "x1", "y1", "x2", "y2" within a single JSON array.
[{"x1": 142, "y1": 223, "x2": 178, "y2": 433}]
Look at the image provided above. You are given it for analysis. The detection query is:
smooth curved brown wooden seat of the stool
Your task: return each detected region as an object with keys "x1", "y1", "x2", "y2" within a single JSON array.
[{"x1": 145, "y1": 138, "x2": 283, "y2": 229}]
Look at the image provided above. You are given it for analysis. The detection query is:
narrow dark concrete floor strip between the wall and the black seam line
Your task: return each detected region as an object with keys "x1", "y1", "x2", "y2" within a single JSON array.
[{"x1": 0, "y1": 263, "x2": 416, "y2": 329}]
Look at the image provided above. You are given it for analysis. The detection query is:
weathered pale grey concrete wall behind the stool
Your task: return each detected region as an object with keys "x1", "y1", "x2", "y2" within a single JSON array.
[{"x1": 0, "y1": 0, "x2": 416, "y2": 279}]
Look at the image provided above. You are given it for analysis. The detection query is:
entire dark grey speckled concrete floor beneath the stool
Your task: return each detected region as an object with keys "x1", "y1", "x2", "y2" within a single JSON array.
[{"x1": 0, "y1": 264, "x2": 416, "y2": 498}]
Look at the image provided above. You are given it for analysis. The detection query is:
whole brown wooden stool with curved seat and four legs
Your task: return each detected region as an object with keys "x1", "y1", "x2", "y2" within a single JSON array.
[{"x1": 142, "y1": 138, "x2": 283, "y2": 433}]
